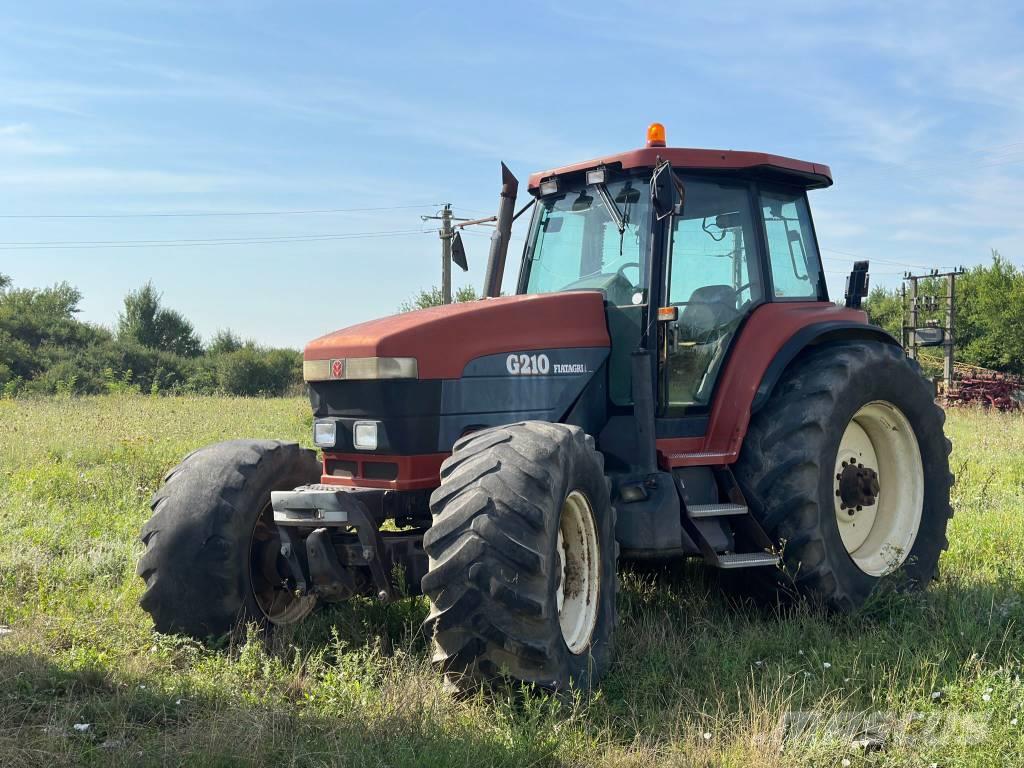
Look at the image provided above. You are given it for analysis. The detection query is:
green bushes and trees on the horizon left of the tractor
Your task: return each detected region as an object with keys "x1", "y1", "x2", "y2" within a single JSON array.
[{"x1": 0, "y1": 274, "x2": 302, "y2": 396}]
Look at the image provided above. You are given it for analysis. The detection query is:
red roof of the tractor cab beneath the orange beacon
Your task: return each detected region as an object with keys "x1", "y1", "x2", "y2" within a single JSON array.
[{"x1": 528, "y1": 146, "x2": 833, "y2": 195}]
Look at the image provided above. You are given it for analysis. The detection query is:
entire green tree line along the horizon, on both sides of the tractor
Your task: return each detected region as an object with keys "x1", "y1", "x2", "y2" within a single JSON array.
[{"x1": 0, "y1": 251, "x2": 1011, "y2": 396}]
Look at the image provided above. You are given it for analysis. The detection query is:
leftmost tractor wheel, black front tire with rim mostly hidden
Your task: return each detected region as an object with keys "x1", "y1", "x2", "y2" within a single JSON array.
[{"x1": 137, "y1": 440, "x2": 321, "y2": 638}]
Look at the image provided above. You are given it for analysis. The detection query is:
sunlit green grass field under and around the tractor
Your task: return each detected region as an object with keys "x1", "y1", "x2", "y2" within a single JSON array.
[{"x1": 0, "y1": 396, "x2": 1024, "y2": 768}]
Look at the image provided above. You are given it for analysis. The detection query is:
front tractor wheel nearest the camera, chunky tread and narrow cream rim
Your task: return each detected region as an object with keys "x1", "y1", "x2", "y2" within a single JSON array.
[{"x1": 423, "y1": 422, "x2": 618, "y2": 690}]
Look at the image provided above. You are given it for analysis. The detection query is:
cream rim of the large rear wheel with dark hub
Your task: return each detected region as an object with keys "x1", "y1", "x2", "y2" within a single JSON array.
[{"x1": 833, "y1": 400, "x2": 925, "y2": 577}]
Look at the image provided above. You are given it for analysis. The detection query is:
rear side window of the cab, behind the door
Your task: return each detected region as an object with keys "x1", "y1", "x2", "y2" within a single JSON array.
[{"x1": 761, "y1": 191, "x2": 824, "y2": 300}]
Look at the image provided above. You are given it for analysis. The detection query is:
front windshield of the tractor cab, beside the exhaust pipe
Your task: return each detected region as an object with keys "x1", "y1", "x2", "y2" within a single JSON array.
[{"x1": 526, "y1": 176, "x2": 651, "y2": 306}]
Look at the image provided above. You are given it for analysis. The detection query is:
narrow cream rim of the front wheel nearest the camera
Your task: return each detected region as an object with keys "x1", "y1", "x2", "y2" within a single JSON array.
[{"x1": 555, "y1": 490, "x2": 601, "y2": 654}]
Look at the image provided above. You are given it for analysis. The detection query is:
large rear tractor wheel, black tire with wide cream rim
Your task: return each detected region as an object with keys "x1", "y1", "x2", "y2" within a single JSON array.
[{"x1": 734, "y1": 341, "x2": 952, "y2": 610}]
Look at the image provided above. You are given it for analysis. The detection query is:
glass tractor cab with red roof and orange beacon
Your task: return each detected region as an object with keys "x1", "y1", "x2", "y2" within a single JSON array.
[{"x1": 517, "y1": 123, "x2": 831, "y2": 417}]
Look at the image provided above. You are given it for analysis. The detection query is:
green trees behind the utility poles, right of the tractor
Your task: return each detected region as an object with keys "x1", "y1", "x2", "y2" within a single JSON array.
[{"x1": 864, "y1": 251, "x2": 1024, "y2": 375}]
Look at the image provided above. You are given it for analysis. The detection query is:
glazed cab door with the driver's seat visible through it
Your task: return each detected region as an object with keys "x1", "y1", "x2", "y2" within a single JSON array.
[{"x1": 658, "y1": 179, "x2": 765, "y2": 417}]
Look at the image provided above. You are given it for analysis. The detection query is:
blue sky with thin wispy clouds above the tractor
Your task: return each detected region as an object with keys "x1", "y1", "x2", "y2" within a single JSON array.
[{"x1": 0, "y1": 0, "x2": 1024, "y2": 346}]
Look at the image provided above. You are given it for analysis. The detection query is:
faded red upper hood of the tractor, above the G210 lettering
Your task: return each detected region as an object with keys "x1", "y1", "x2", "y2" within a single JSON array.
[{"x1": 304, "y1": 291, "x2": 610, "y2": 379}]
